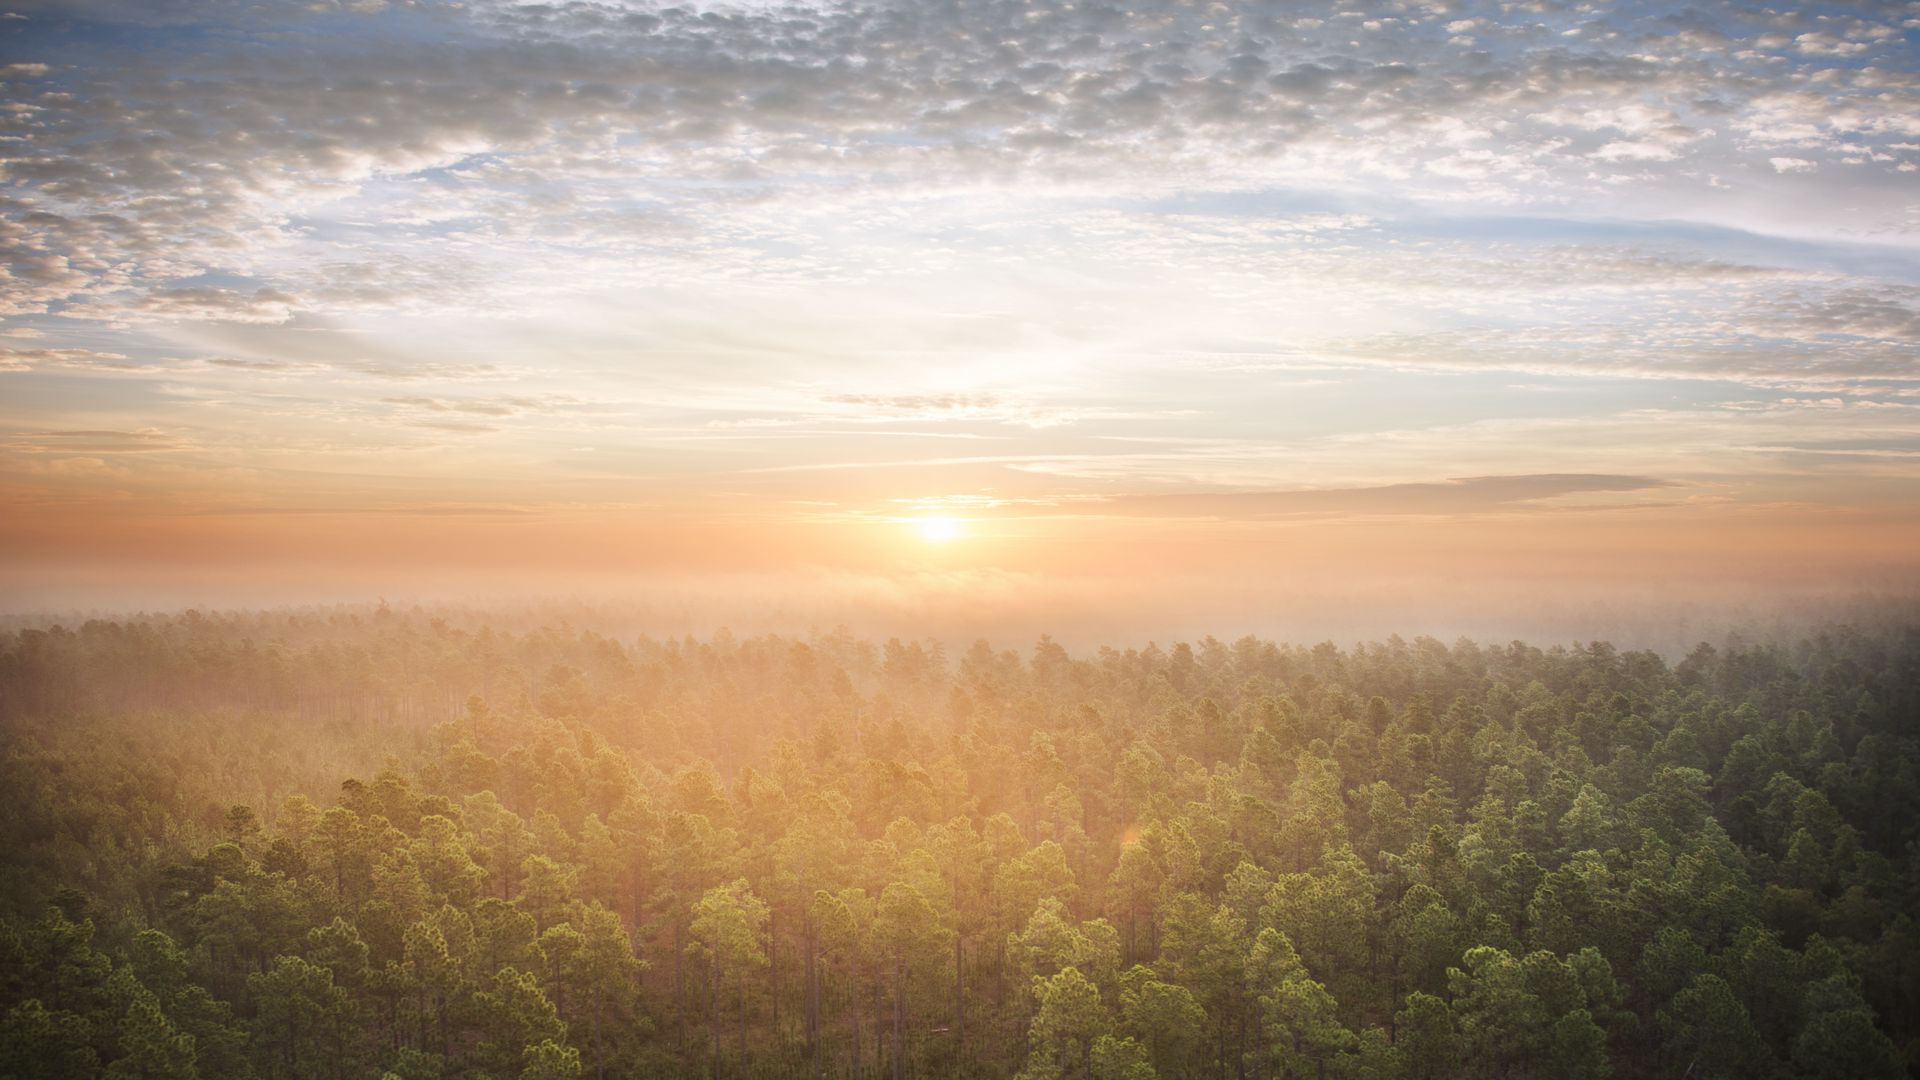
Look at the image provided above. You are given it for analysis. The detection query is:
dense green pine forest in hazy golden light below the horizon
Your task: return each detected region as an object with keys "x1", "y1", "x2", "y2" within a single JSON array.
[{"x1": 0, "y1": 607, "x2": 1920, "y2": 1080}]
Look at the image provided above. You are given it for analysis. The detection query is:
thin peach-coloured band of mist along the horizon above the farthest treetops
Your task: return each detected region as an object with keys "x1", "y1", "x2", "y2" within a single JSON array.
[{"x1": 4, "y1": 567, "x2": 1920, "y2": 661}]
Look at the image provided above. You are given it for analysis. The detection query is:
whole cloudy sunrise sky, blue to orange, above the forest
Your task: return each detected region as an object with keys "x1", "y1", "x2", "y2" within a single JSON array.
[{"x1": 0, "y1": 0, "x2": 1920, "y2": 628}]
